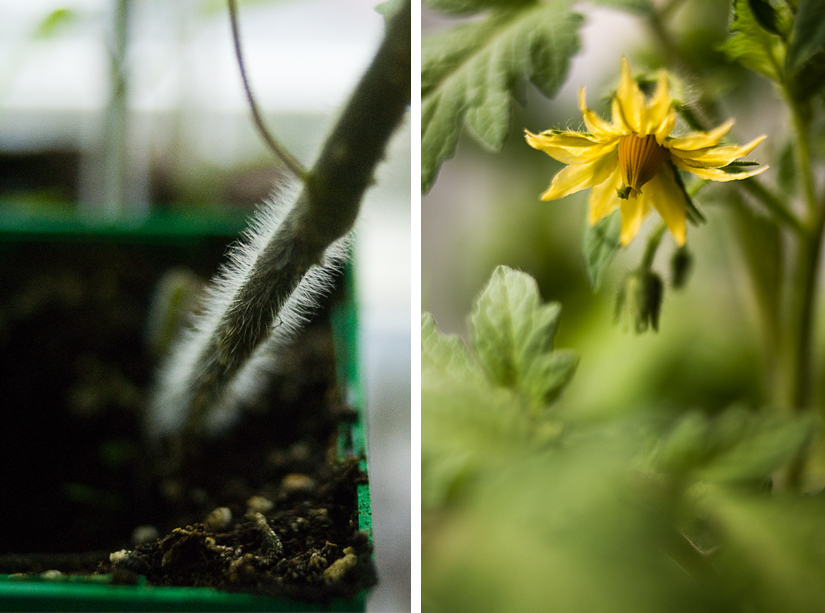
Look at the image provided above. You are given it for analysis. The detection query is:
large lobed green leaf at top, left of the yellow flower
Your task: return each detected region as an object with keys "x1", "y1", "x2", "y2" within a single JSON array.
[{"x1": 421, "y1": 0, "x2": 582, "y2": 192}]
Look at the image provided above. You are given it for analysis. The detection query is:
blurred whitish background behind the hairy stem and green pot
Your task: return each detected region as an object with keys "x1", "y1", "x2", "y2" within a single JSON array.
[{"x1": 0, "y1": 0, "x2": 411, "y2": 611}]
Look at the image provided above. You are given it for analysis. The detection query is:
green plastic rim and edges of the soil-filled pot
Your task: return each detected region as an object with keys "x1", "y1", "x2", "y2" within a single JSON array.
[{"x1": 0, "y1": 208, "x2": 372, "y2": 611}]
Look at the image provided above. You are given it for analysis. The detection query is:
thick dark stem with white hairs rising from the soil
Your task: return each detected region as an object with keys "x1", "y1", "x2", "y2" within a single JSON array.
[{"x1": 185, "y1": 0, "x2": 411, "y2": 438}]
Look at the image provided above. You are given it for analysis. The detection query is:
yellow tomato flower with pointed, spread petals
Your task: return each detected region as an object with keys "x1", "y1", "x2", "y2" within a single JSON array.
[{"x1": 525, "y1": 58, "x2": 768, "y2": 245}]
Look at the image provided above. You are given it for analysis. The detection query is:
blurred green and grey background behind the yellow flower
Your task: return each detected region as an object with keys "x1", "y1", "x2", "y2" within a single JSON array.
[{"x1": 421, "y1": 0, "x2": 787, "y2": 415}]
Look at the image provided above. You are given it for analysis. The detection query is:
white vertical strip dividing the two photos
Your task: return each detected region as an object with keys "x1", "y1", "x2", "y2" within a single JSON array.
[{"x1": 410, "y1": 0, "x2": 421, "y2": 611}]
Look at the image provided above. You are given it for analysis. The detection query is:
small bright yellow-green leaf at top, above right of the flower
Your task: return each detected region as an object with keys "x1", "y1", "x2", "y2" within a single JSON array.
[{"x1": 721, "y1": 0, "x2": 785, "y2": 83}]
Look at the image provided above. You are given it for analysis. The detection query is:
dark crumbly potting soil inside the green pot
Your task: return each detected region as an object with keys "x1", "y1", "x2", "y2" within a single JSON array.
[{"x1": 0, "y1": 239, "x2": 375, "y2": 600}]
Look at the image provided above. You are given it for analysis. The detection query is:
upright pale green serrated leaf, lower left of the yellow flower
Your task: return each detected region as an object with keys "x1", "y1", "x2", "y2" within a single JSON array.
[{"x1": 470, "y1": 266, "x2": 576, "y2": 406}]
